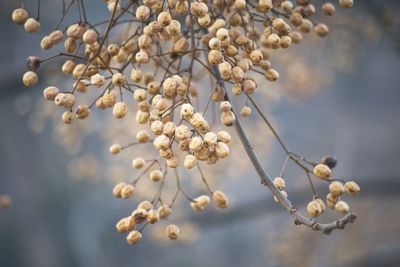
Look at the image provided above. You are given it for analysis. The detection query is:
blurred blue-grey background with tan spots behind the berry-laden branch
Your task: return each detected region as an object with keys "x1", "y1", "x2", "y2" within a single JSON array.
[{"x1": 0, "y1": 0, "x2": 400, "y2": 267}]
